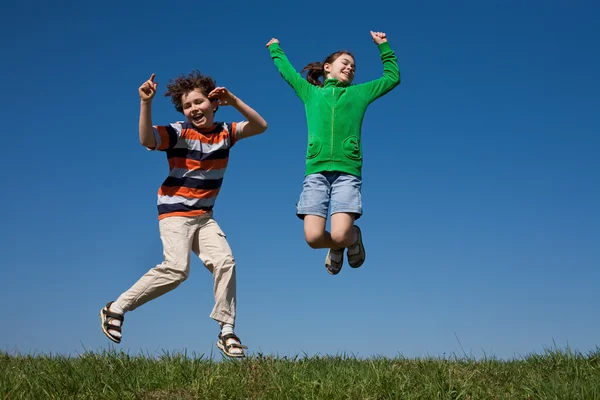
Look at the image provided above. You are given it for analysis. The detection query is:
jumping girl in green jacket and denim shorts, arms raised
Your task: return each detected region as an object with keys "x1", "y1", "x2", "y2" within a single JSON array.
[{"x1": 267, "y1": 32, "x2": 400, "y2": 275}]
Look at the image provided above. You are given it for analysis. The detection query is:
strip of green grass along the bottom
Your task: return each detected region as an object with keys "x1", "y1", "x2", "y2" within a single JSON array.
[{"x1": 0, "y1": 348, "x2": 600, "y2": 400}]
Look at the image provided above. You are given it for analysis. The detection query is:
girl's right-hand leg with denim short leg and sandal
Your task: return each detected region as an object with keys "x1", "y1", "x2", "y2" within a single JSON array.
[{"x1": 331, "y1": 173, "x2": 365, "y2": 268}]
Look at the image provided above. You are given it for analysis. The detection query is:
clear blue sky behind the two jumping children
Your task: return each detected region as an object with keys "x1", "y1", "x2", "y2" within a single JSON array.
[{"x1": 0, "y1": 0, "x2": 600, "y2": 358}]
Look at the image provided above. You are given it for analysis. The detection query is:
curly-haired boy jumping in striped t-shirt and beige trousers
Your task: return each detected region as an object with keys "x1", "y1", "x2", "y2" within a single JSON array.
[{"x1": 100, "y1": 71, "x2": 267, "y2": 357}]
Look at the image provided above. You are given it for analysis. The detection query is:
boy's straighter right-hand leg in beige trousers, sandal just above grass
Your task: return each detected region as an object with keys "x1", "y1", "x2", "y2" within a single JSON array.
[{"x1": 192, "y1": 215, "x2": 247, "y2": 357}]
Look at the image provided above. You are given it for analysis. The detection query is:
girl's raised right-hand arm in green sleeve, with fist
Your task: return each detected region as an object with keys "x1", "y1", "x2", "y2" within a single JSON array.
[{"x1": 356, "y1": 32, "x2": 400, "y2": 103}]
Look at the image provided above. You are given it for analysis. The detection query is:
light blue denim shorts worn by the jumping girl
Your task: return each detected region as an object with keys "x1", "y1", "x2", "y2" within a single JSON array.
[{"x1": 296, "y1": 172, "x2": 362, "y2": 219}]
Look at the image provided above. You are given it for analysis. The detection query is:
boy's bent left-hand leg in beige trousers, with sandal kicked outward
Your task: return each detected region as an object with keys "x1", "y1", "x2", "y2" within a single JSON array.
[{"x1": 103, "y1": 217, "x2": 198, "y2": 340}]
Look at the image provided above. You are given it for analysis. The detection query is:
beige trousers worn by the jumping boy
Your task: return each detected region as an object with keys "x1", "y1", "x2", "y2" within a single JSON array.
[{"x1": 116, "y1": 214, "x2": 236, "y2": 324}]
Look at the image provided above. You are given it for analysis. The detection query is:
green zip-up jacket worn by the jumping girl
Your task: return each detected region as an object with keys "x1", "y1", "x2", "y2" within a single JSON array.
[{"x1": 269, "y1": 42, "x2": 400, "y2": 176}]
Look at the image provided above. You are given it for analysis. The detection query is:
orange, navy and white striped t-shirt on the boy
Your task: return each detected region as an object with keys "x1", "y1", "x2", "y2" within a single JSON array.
[{"x1": 150, "y1": 122, "x2": 243, "y2": 220}]
